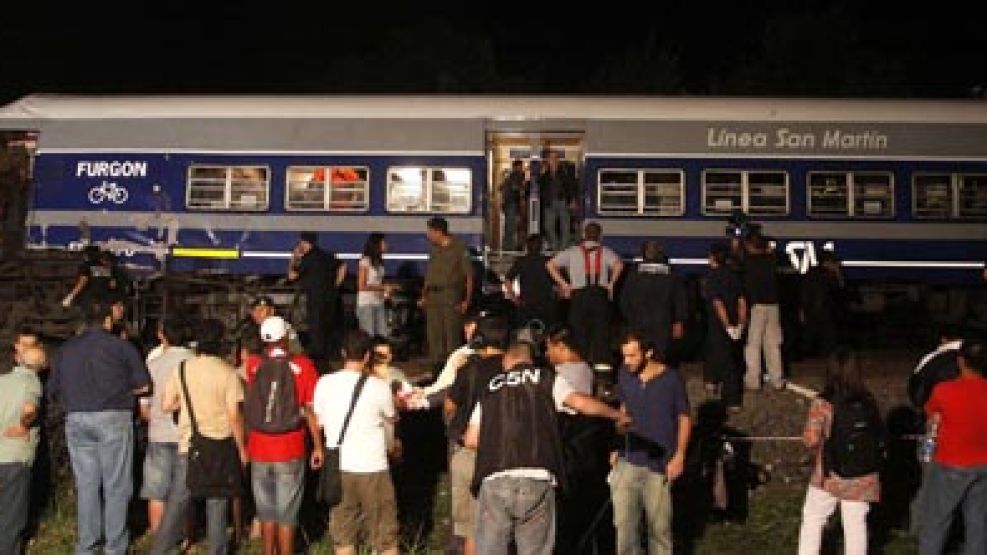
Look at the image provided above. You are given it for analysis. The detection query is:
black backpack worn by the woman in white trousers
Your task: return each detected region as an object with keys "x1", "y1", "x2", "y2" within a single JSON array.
[{"x1": 823, "y1": 398, "x2": 884, "y2": 478}]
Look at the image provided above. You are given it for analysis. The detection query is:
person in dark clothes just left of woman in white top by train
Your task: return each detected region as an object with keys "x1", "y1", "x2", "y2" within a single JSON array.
[{"x1": 288, "y1": 231, "x2": 346, "y2": 370}]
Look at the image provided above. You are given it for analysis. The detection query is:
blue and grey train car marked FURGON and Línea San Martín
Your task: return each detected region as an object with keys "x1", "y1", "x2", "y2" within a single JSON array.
[{"x1": 0, "y1": 95, "x2": 987, "y2": 283}]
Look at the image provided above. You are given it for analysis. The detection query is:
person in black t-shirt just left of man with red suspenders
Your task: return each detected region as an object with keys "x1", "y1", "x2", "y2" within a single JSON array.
[{"x1": 504, "y1": 233, "x2": 558, "y2": 329}]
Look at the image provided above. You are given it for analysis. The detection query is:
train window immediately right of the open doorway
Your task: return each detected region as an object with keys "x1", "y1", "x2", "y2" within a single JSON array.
[{"x1": 597, "y1": 170, "x2": 685, "y2": 216}]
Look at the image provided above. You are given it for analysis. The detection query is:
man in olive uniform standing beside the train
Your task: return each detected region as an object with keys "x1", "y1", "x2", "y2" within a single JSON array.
[{"x1": 420, "y1": 217, "x2": 473, "y2": 372}]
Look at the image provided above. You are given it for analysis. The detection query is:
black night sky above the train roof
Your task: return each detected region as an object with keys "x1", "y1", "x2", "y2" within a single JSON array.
[{"x1": 0, "y1": 0, "x2": 987, "y2": 102}]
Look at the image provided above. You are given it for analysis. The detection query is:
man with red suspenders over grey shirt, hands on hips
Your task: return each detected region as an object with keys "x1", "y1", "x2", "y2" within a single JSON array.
[{"x1": 545, "y1": 222, "x2": 624, "y2": 369}]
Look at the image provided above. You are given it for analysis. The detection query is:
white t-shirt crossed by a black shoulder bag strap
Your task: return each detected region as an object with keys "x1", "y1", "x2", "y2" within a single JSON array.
[{"x1": 312, "y1": 369, "x2": 396, "y2": 473}]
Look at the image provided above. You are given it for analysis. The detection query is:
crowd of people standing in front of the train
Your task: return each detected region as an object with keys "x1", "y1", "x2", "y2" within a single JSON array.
[{"x1": 0, "y1": 214, "x2": 987, "y2": 555}]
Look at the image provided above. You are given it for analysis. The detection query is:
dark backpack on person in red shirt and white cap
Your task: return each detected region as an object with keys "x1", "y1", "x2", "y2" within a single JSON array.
[{"x1": 243, "y1": 356, "x2": 302, "y2": 434}]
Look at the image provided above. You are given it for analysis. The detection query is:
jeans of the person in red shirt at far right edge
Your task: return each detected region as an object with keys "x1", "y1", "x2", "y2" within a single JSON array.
[{"x1": 918, "y1": 462, "x2": 987, "y2": 555}]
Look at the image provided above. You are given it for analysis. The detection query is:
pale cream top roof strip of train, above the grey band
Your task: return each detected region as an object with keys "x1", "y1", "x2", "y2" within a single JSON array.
[{"x1": 0, "y1": 94, "x2": 987, "y2": 125}]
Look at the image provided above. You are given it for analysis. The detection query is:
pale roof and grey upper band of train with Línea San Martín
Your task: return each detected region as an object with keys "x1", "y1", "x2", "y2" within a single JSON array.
[{"x1": 0, "y1": 94, "x2": 987, "y2": 160}]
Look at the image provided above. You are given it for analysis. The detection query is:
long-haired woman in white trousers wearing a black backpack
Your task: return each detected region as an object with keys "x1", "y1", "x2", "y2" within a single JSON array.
[{"x1": 798, "y1": 350, "x2": 882, "y2": 555}]
